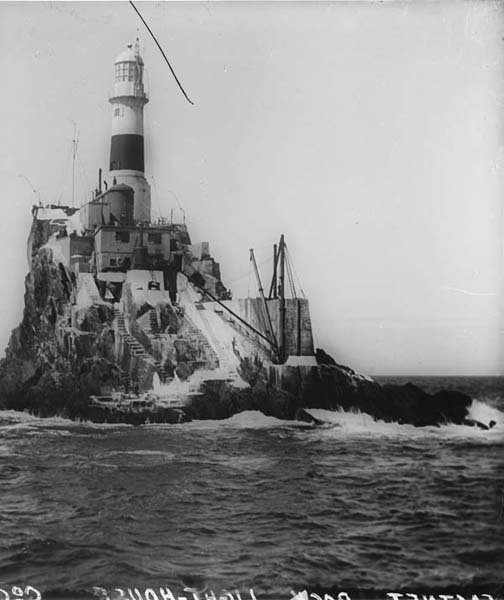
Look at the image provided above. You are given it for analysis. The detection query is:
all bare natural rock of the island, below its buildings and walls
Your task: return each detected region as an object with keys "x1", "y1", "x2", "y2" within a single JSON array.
[{"x1": 0, "y1": 247, "x2": 471, "y2": 426}]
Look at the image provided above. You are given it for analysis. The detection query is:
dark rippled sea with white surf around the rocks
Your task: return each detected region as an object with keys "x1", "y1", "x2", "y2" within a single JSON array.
[{"x1": 0, "y1": 377, "x2": 504, "y2": 600}]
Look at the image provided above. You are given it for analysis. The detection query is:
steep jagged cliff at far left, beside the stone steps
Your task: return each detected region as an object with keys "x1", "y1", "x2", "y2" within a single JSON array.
[{"x1": 0, "y1": 248, "x2": 120, "y2": 417}]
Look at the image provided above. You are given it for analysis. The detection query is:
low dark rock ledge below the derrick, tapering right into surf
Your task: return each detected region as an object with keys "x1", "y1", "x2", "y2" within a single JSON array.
[{"x1": 185, "y1": 350, "x2": 472, "y2": 427}]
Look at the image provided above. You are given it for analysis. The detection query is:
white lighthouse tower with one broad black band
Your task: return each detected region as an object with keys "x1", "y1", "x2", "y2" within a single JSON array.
[{"x1": 109, "y1": 39, "x2": 151, "y2": 222}]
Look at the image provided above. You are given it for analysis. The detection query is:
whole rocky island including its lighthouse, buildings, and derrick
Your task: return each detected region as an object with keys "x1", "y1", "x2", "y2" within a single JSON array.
[{"x1": 0, "y1": 43, "x2": 471, "y2": 426}]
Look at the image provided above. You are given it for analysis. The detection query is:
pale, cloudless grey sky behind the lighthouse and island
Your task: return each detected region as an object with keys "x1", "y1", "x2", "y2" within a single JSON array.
[{"x1": 0, "y1": 0, "x2": 504, "y2": 375}]
